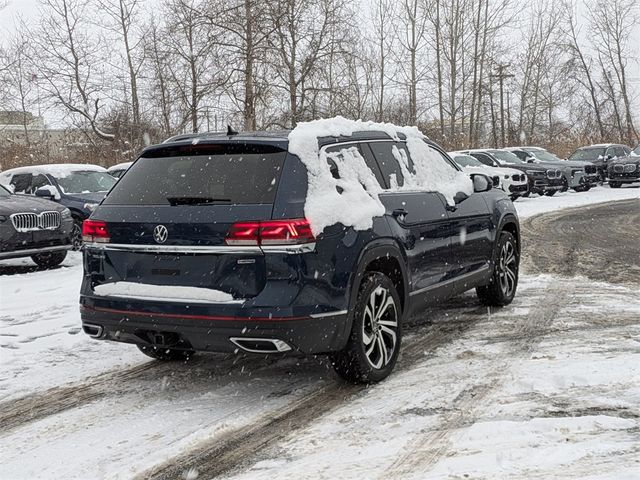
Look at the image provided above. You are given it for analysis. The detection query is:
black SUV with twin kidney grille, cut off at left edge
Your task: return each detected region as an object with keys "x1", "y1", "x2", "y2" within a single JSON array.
[{"x1": 0, "y1": 185, "x2": 73, "y2": 268}]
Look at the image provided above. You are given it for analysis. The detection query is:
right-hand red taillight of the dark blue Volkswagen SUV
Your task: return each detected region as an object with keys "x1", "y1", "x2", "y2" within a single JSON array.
[{"x1": 225, "y1": 218, "x2": 315, "y2": 245}]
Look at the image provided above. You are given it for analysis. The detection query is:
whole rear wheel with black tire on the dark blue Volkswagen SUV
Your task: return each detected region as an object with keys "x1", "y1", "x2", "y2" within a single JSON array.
[{"x1": 332, "y1": 272, "x2": 402, "y2": 383}]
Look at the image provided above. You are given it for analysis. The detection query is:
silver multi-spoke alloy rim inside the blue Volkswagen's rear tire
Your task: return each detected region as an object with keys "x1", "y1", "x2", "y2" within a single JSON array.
[{"x1": 362, "y1": 286, "x2": 398, "y2": 369}]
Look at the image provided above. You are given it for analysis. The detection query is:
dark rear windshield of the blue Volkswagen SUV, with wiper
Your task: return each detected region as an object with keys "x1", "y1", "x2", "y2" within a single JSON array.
[{"x1": 103, "y1": 144, "x2": 286, "y2": 205}]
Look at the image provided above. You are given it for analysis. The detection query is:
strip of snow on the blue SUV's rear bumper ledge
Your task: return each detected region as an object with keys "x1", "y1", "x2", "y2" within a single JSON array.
[{"x1": 94, "y1": 282, "x2": 234, "y2": 303}]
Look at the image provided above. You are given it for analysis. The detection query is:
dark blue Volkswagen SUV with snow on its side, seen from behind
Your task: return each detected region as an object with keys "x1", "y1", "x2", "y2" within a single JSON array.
[{"x1": 80, "y1": 126, "x2": 520, "y2": 382}]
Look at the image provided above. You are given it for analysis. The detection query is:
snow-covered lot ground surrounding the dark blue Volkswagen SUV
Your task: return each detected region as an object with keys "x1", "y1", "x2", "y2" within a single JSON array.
[{"x1": 0, "y1": 186, "x2": 640, "y2": 479}]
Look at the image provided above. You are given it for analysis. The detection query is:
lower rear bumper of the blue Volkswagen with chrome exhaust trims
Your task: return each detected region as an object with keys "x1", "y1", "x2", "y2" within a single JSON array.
[{"x1": 80, "y1": 297, "x2": 349, "y2": 354}]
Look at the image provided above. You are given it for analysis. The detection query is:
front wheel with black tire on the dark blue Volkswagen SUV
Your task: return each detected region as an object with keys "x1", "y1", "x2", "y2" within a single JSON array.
[{"x1": 476, "y1": 232, "x2": 520, "y2": 307}]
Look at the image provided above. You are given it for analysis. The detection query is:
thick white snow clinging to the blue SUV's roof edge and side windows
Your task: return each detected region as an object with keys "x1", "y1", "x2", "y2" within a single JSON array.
[{"x1": 289, "y1": 117, "x2": 473, "y2": 235}]
